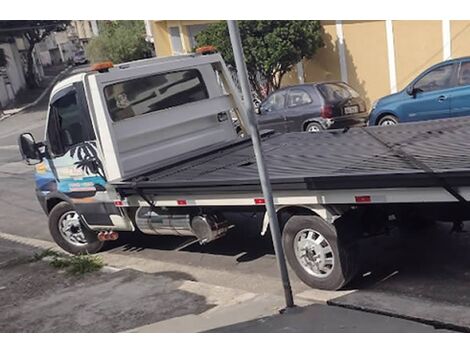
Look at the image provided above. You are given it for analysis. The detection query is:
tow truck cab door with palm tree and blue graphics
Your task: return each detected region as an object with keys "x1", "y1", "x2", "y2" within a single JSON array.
[{"x1": 36, "y1": 84, "x2": 106, "y2": 198}]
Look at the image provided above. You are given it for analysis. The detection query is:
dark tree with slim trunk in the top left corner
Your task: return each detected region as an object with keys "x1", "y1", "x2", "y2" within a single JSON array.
[{"x1": 0, "y1": 20, "x2": 70, "y2": 88}]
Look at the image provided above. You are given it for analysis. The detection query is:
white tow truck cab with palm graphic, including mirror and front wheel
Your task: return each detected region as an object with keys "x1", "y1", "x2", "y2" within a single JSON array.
[{"x1": 19, "y1": 54, "x2": 246, "y2": 253}]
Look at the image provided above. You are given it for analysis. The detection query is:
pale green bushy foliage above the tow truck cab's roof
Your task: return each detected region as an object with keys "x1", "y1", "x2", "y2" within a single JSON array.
[{"x1": 86, "y1": 21, "x2": 151, "y2": 64}]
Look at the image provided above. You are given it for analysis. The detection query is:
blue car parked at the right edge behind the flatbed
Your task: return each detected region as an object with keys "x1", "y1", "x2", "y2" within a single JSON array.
[{"x1": 369, "y1": 57, "x2": 470, "y2": 126}]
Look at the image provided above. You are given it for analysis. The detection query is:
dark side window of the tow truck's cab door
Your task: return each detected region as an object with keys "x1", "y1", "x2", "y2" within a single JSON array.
[{"x1": 47, "y1": 92, "x2": 86, "y2": 155}]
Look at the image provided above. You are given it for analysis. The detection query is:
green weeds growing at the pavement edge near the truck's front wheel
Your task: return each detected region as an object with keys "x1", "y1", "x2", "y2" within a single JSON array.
[{"x1": 34, "y1": 249, "x2": 104, "y2": 275}]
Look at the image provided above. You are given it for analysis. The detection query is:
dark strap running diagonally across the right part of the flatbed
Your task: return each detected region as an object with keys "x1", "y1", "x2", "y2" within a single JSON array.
[{"x1": 363, "y1": 127, "x2": 468, "y2": 203}]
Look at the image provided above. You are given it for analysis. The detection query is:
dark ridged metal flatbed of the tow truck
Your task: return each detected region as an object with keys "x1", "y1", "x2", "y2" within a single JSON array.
[{"x1": 114, "y1": 117, "x2": 470, "y2": 196}]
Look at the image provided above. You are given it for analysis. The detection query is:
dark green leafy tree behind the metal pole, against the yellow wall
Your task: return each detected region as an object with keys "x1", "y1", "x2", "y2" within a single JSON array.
[{"x1": 196, "y1": 21, "x2": 323, "y2": 97}]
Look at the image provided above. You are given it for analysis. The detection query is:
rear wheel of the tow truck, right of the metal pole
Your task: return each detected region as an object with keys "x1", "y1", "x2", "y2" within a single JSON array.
[{"x1": 282, "y1": 215, "x2": 357, "y2": 290}]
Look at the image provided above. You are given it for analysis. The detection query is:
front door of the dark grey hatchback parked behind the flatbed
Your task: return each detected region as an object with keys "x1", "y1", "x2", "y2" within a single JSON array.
[{"x1": 257, "y1": 91, "x2": 286, "y2": 132}]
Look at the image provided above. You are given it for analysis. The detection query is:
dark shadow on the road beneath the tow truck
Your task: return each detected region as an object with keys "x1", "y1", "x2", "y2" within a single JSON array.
[{"x1": 104, "y1": 220, "x2": 470, "y2": 305}]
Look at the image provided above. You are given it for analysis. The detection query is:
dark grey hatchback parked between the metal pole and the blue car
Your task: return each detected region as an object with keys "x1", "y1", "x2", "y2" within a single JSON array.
[{"x1": 257, "y1": 82, "x2": 368, "y2": 132}]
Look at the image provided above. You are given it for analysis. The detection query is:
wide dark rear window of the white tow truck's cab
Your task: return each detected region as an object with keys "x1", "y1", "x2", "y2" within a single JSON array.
[{"x1": 104, "y1": 69, "x2": 209, "y2": 121}]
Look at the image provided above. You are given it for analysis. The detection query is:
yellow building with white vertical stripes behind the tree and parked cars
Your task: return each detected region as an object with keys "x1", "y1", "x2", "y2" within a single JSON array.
[{"x1": 151, "y1": 20, "x2": 470, "y2": 105}]
